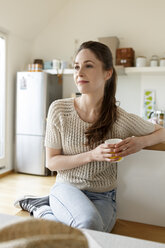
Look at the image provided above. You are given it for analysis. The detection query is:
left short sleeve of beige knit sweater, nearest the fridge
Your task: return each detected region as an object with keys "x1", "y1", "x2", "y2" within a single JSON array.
[{"x1": 45, "y1": 101, "x2": 62, "y2": 149}]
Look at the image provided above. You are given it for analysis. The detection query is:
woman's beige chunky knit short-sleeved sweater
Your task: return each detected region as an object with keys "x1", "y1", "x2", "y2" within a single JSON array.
[{"x1": 45, "y1": 98, "x2": 154, "y2": 192}]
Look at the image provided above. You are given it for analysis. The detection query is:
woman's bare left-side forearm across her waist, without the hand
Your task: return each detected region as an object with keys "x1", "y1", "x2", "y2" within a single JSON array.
[{"x1": 46, "y1": 151, "x2": 92, "y2": 171}]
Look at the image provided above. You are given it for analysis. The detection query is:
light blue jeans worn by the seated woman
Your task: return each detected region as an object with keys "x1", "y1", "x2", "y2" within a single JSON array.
[{"x1": 38, "y1": 183, "x2": 116, "y2": 232}]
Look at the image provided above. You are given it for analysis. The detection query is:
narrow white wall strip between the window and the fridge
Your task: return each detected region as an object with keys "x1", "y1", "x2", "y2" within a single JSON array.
[{"x1": 6, "y1": 33, "x2": 31, "y2": 170}]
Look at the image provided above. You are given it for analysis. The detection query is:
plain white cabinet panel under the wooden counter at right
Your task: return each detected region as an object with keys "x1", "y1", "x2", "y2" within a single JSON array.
[{"x1": 117, "y1": 150, "x2": 165, "y2": 226}]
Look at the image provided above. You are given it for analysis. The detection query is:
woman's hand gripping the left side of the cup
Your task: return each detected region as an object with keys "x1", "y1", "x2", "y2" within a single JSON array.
[{"x1": 91, "y1": 144, "x2": 118, "y2": 162}]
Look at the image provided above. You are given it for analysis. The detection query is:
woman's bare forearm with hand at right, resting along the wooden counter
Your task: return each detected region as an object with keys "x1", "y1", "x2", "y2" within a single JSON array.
[{"x1": 114, "y1": 125, "x2": 165, "y2": 157}]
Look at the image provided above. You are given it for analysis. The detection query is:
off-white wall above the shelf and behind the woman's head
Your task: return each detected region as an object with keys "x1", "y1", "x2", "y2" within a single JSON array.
[{"x1": 33, "y1": 0, "x2": 165, "y2": 65}]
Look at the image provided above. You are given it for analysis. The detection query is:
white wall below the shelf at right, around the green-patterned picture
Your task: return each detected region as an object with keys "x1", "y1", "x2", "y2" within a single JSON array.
[{"x1": 116, "y1": 72, "x2": 165, "y2": 117}]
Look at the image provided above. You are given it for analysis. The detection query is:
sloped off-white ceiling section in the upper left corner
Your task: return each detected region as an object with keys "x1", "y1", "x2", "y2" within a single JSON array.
[{"x1": 0, "y1": 0, "x2": 70, "y2": 41}]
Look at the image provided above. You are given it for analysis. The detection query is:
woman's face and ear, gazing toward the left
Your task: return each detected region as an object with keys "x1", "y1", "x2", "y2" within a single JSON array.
[{"x1": 74, "y1": 49, "x2": 112, "y2": 94}]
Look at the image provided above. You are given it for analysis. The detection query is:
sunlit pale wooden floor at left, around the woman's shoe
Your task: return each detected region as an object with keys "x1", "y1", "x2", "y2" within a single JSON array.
[{"x1": 0, "y1": 173, "x2": 55, "y2": 216}]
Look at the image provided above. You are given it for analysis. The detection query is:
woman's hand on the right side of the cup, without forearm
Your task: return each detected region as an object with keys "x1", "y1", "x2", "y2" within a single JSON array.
[{"x1": 114, "y1": 136, "x2": 145, "y2": 157}]
